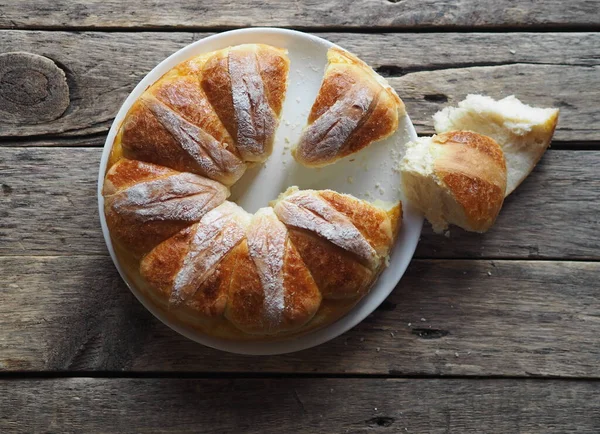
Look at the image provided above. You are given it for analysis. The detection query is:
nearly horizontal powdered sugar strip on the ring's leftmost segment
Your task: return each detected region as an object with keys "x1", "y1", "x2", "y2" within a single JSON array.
[{"x1": 107, "y1": 173, "x2": 229, "y2": 222}]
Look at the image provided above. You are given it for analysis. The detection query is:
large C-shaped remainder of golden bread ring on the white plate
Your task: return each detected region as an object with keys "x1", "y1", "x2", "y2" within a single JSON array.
[{"x1": 103, "y1": 45, "x2": 402, "y2": 340}]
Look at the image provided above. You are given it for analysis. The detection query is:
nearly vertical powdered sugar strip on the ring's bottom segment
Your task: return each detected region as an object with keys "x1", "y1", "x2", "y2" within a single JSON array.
[{"x1": 248, "y1": 208, "x2": 287, "y2": 327}]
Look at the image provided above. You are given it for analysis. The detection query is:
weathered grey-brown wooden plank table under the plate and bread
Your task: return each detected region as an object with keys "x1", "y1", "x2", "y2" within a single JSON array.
[{"x1": 0, "y1": 0, "x2": 600, "y2": 433}]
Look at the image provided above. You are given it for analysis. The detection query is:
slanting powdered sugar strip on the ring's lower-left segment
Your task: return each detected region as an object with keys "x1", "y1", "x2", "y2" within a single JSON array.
[{"x1": 170, "y1": 202, "x2": 248, "y2": 304}]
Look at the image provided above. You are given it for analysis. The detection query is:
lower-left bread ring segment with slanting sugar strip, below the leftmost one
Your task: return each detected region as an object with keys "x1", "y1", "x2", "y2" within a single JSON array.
[{"x1": 140, "y1": 202, "x2": 250, "y2": 317}]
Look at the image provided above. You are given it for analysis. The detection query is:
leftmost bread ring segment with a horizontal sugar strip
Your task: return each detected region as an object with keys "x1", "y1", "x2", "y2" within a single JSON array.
[{"x1": 103, "y1": 159, "x2": 229, "y2": 256}]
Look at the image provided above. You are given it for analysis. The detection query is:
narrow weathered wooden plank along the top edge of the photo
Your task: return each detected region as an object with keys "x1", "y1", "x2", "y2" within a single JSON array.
[{"x1": 0, "y1": 0, "x2": 600, "y2": 29}]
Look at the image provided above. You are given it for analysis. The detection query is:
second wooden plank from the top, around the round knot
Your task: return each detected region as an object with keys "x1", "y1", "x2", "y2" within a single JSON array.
[{"x1": 0, "y1": 31, "x2": 600, "y2": 145}]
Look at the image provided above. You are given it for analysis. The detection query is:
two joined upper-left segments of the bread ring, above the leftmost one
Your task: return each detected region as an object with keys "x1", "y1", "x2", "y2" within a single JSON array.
[{"x1": 117, "y1": 44, "x2": 289, "y2": 185}]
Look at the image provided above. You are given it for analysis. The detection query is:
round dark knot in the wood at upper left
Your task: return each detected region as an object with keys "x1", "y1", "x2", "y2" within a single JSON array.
[{"x1": 0, "y1": 52, "x2": 70, "y2": 124}]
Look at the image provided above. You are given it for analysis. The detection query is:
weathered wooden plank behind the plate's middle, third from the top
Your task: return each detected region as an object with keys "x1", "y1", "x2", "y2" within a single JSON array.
[{"x1": 0, "y1": 148, "x2": 600, "y2": 259}]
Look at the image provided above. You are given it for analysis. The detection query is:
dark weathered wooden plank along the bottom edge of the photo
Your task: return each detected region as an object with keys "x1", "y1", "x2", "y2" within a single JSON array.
[{"x1": 0, "y1": 378, "x2": 600, "y2": 434}]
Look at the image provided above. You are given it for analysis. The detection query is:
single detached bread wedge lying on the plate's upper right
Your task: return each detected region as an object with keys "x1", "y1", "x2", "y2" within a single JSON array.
[{"x1": 292, "y1": 48, "x2": 405, "y2": 167}]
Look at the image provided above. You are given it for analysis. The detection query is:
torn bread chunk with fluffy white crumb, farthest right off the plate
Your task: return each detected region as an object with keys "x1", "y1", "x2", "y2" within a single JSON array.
[{"x1": 433, "y1": 95, "x2": 559, "y2": 196}]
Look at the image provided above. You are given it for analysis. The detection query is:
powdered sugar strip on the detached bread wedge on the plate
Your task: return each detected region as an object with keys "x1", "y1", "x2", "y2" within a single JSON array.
[{"x1": 296, "y1": 84, "x2": 378, "y2": 164}]
